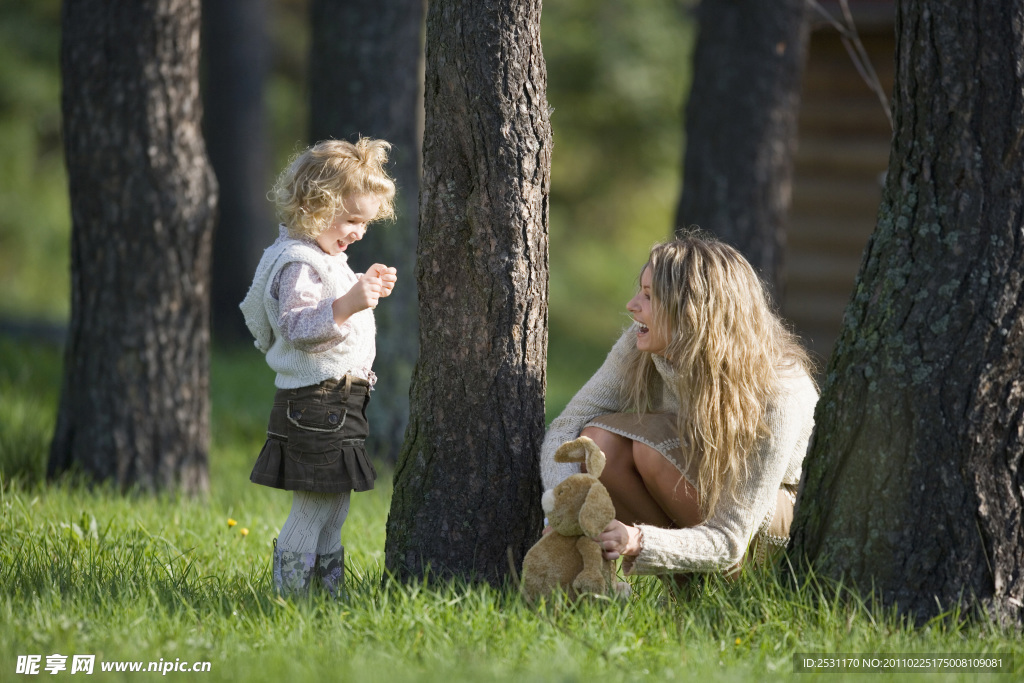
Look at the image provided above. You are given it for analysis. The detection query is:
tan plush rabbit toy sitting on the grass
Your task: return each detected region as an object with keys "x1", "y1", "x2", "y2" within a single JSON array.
[{"x1": 519, "y1": 436, "x2": 617, "y2": 601}]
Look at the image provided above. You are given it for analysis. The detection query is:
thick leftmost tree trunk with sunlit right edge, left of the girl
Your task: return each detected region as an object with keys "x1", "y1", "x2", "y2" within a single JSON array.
[{"x1": 48, "y1": 0, "x2": 216, "y2": 493}]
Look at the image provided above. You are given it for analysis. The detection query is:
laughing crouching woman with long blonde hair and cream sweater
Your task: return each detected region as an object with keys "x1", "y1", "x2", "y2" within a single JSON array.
[{"x1": 541, "y1": 236, "x2": 818, "y2": 574}]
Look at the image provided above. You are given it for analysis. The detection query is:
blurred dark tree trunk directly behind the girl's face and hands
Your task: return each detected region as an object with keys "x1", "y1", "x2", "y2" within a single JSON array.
[{"x1": 309, "y1": 0, "x2": 425, "y2": 463}]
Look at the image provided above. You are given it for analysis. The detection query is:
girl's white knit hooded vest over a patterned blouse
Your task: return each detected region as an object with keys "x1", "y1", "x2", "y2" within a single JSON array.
[{"x1": 240, "y1": 227, "x2": 376, "y2": 389}]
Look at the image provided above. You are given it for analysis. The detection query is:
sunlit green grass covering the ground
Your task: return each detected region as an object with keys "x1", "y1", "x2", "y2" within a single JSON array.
[{"x1": 0, "y1": 338, "x2": 1024, "y2": 683}]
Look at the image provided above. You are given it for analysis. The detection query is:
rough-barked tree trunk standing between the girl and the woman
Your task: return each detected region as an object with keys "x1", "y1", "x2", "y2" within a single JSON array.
[{"x1": 385, "y1": 0, "x2": 551, "y2": 584}]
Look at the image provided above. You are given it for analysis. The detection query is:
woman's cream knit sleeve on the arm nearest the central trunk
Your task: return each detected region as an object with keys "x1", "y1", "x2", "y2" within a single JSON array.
[{"x1": 541, "y1": 326, "x2": 636, "y2": 489}]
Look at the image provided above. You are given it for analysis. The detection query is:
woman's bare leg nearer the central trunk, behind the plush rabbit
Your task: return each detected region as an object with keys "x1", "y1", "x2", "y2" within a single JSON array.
[{"x1": 581, "y1": 427, "x2": 678, "y2": 527}]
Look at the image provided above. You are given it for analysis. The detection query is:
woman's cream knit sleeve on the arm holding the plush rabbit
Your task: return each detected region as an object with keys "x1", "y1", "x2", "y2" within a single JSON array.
[{"x1": 632, "y1": 375, "x2": 817, "y2": 573}]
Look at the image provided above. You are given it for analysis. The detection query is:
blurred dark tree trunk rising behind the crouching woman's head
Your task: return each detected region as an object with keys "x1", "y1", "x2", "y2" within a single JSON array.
[{"x1": 676, "y1": 0, "x2": 809, "y2": 301}]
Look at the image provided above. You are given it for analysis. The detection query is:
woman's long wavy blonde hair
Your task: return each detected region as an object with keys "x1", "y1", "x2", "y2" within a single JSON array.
[{"x1": 625, "y1": 233, "x2": 812, "y2": 519}]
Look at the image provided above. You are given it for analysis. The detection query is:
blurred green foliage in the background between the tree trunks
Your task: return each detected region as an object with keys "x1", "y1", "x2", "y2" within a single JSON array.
[{"x1": 0, "y1": 0, "x2": 694, "y2": 420}]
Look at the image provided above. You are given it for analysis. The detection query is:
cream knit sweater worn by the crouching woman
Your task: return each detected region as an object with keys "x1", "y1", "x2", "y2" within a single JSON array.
[{"x1": 541, "y1": 326, "x2": 818, "y2": 573}]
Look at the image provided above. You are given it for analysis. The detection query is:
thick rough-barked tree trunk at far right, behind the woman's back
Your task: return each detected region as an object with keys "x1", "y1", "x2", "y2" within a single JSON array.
[{"x1": 793, "y1": 0, "x2": 1024, "y2": 624}]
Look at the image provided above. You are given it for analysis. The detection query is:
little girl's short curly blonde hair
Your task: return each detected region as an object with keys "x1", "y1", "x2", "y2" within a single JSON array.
[{"x1": 268, "y1": 137, "x2": 395, "y2": 239}]
